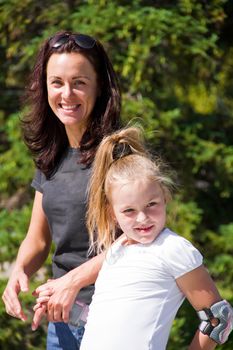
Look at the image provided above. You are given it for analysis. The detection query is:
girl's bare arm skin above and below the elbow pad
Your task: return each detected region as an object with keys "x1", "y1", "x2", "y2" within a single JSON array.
[{"x1": 176, "y1": 266, "x2": 222, "y2": 350}]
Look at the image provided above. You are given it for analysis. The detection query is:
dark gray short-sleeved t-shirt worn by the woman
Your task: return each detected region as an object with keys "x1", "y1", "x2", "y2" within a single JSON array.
[{"x1": 32, "y1": 148, "x2": 94, "y2": 304}]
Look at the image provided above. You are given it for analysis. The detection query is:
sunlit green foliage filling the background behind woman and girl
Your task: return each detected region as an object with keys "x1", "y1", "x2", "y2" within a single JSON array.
[{"x1": 0, "y1": 0, "x2": 233, "y2": 350}]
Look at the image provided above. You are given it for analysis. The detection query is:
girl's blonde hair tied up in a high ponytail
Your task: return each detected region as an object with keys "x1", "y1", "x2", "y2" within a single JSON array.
[{"x1": 87, "y1": 127, "x2": 174, "y2": 253}]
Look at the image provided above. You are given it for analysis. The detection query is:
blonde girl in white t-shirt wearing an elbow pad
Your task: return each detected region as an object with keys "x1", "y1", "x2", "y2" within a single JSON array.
[{"x1": 81, "y1": 128, "x2": 233, "y2": 350}]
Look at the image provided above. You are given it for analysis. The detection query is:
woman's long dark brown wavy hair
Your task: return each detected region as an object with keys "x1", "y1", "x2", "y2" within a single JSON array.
[{"x1": 21, "y1": 31, "x2": 121, "y2": 177}]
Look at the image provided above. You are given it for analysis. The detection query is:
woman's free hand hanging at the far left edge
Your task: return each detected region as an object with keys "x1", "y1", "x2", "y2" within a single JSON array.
[{"x1": 2, "y1": 270, "x2": 29, "y2": 321}]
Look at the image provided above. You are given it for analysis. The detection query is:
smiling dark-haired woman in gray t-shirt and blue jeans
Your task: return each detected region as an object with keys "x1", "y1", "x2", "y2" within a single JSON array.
[{"x1": 3, "y1": 32, "x2": 121, "y2": 350}]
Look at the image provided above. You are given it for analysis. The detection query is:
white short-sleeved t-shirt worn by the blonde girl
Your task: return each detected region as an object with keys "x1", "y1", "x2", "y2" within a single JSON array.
[{"x1": 80, "y1": 229, "x2": 202, "y2": 350}]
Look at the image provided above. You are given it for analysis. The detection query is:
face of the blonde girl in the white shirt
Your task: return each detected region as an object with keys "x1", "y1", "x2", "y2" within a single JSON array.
[{"x1": 111, "y1": 180, "x2": 166, "y2": 244}]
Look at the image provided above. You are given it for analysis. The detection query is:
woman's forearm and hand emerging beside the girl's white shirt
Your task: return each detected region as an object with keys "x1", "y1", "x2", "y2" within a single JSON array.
[{"x1": 32, "y1": 253, "x2": 105, "y2": 330}]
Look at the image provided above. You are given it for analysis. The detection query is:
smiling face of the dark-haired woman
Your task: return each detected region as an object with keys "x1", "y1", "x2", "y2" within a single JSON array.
[{"x1": 47, "y1": 52, "x2": 98, "y2": 141}]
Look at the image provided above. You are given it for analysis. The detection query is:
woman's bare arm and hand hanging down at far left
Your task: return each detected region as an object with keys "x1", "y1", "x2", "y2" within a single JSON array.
[{"x1": 2, "y1": 192, "x2": 51, "y2": 321}]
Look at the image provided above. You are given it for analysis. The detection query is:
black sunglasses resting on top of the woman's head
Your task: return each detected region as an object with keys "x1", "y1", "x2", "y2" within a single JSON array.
[{"x1": 51, "y1": 33, "x2": 96, "y2": 49}]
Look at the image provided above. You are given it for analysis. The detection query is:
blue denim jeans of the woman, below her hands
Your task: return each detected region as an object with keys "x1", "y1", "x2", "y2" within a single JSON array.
[{"x1": 47, "y1": 322, "x2": 84, "y2": 350}]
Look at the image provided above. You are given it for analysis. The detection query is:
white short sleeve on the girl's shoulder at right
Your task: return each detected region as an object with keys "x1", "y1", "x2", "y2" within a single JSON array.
[{"x1": 163, "y1": 235, "x2": 203, "y2": 279}]
